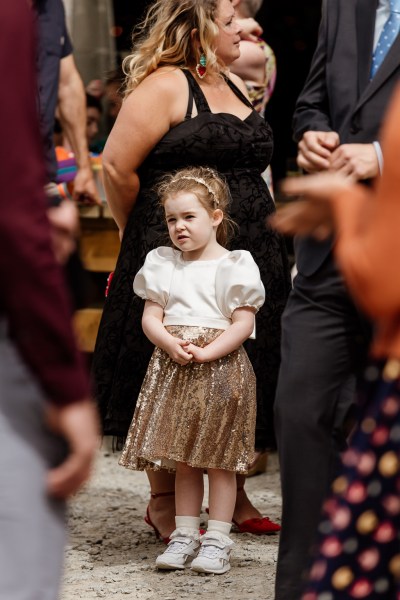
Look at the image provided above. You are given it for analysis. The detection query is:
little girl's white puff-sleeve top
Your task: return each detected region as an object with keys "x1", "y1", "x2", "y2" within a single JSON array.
[{"x1": 133, "y1": 246, "x2": 265, "y2": 338}]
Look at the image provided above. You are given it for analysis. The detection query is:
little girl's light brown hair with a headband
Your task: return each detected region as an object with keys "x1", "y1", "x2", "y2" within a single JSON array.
[{"x1": 157, "y1": 167, "x2": 237, "y2": 246}]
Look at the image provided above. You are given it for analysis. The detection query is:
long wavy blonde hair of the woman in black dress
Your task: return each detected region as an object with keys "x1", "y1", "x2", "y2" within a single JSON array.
[{"x1": 122, "y1": 0, "x2": 223, "y2": 95}]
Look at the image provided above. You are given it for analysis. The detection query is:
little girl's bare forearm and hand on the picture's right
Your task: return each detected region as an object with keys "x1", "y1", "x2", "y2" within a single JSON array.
[{"x1": 185, "y1": 306, "x2": 255, "y2": 363}]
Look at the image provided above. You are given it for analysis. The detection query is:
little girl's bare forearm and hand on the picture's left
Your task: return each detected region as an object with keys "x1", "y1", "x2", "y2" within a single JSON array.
[{"x1": 142, "y1": 300, "x2": 192, "y2": 365}]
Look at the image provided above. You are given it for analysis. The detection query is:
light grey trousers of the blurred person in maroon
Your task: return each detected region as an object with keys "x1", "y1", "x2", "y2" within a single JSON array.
[{"x1": 0, "y1": 320, "x2": 65, "y2": 600}]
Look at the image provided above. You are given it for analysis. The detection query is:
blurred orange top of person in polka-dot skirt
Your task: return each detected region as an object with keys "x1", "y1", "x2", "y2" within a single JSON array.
[{"x1": 334, "y1": 88, "x2": 400, "y2": 358}]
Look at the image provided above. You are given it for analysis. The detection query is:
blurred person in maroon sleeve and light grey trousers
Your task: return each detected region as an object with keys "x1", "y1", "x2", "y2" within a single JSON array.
[{"x1": 0, "y1": 0, "x2": 98, "y2": 600}]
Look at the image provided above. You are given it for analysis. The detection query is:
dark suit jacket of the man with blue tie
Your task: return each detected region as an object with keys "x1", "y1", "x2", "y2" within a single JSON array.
[{"x1": 293, "y1": 0, "x2": 400, "y2": 276}]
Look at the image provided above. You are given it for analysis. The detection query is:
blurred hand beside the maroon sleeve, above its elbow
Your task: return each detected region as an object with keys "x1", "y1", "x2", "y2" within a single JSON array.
[{"x1": 47, "y1": 200, "x2": 79, "y2": 265}]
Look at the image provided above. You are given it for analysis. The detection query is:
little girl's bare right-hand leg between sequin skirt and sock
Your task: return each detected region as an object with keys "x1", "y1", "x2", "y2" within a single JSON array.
[{"x1": 208, "y1": 469, "x2": 236, "y2": 523}]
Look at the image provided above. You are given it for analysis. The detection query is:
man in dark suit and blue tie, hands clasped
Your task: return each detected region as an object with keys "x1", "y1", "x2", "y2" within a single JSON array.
[{"x1": 275, "y1": 0, "x2": 400, "y2": 600}]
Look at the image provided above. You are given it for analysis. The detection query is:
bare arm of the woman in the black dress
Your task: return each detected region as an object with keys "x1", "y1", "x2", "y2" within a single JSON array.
[{"x1": 103, "y1": 69, "x2": 188, "y2": 233}]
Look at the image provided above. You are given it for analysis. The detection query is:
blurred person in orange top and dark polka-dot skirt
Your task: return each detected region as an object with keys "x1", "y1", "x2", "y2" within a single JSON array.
[{"x1": 272, "y1": 88, "x2": 400, "y2": 600}]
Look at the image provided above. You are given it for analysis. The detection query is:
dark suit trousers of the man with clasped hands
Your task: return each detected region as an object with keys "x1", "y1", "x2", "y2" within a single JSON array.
[{"x1": 275, "y1": 260, "x2": 369, "y2": 600}]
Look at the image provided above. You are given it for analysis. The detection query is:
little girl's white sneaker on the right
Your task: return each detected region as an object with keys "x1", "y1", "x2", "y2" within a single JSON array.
[{"x1": 192, "y1": 531, "x2": 233, "y2": 574}]
